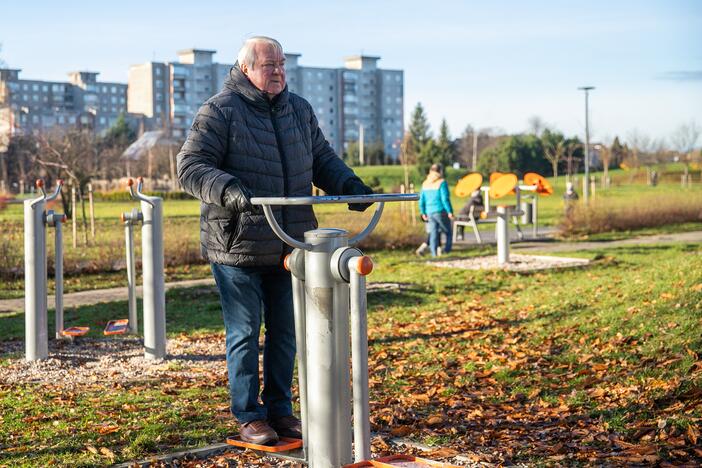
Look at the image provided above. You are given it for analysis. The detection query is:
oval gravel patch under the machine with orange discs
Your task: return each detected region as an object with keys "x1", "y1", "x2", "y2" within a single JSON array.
[{"x1": 434, "y1": 253, "x2": 590, "y2": 271}]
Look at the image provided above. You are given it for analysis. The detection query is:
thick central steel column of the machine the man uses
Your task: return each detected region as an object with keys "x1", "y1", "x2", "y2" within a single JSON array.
[{"x1": 305, "y1": 229, "x2": 352, "y2": 468}]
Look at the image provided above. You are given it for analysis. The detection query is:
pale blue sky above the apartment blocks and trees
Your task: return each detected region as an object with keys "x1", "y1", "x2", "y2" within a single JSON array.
[{"x1": 0, "y1": 0, "x2": 702, "y2": 143}]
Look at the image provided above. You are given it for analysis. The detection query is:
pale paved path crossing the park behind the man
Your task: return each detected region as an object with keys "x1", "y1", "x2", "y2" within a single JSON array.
[{"x1": 0, "y1": 228, "x2": 702, "y2": 312}]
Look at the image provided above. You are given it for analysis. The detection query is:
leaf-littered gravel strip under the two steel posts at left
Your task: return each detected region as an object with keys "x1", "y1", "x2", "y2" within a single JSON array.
[{"x1": 0, "y1": 335, "x2": 227, "y2": 388}]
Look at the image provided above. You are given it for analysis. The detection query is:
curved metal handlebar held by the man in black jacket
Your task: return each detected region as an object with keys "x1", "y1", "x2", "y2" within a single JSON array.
[{"x1": 251, "y1": 193, "x2": 419, "y2": 250}]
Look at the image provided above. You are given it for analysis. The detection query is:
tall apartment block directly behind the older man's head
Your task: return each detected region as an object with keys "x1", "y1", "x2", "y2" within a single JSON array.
[{"x1": 127, "y1": 49, "x2": 404, "y2": 159}]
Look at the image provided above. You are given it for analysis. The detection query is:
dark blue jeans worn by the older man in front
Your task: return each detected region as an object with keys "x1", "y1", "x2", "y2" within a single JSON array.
[{"x1": 210, "y1": 263, "x2": 295, "y2": 423}]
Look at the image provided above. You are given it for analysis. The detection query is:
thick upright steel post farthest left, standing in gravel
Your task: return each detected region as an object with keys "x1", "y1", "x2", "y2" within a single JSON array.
[{"x1": 24, "y1": 196, "x2": 49, "y2": 361}]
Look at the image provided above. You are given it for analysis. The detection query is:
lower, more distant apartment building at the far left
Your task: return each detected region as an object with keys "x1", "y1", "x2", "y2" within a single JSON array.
[{"x1": 0, "y1": 68, "x2": 127, "y2": 132}]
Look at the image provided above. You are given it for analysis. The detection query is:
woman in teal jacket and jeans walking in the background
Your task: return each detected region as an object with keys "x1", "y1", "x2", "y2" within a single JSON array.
[{"x1": 419, "y1": 164, "x2": 453, "y2": 257}]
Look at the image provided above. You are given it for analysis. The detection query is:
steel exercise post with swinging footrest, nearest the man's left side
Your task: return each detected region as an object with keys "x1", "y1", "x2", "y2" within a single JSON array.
[{"x1": 120, "y1": 177, "x2": 166, "y2": 359}]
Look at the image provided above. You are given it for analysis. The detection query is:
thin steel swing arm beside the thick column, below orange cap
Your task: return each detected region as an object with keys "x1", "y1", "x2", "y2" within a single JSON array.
[{"x1": 348, "y1": 257, "x2": 371, "y2": 463}]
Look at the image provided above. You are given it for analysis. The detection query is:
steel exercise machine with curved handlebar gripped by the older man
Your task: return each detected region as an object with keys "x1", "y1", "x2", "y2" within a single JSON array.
[{"x1": 227, "y1": 194, "x2": 454, "y2": 468}]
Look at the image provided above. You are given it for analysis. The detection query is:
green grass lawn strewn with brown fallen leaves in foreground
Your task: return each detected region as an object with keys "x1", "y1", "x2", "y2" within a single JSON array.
[{"x1": 0, "y1": 239, "x2": 702, "y2": 466}]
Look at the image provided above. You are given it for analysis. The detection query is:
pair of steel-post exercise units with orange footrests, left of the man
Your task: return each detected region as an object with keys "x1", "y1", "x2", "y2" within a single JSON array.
[{"x1": 24, "y1": 176, "x2": 166, "y2": 361}]
